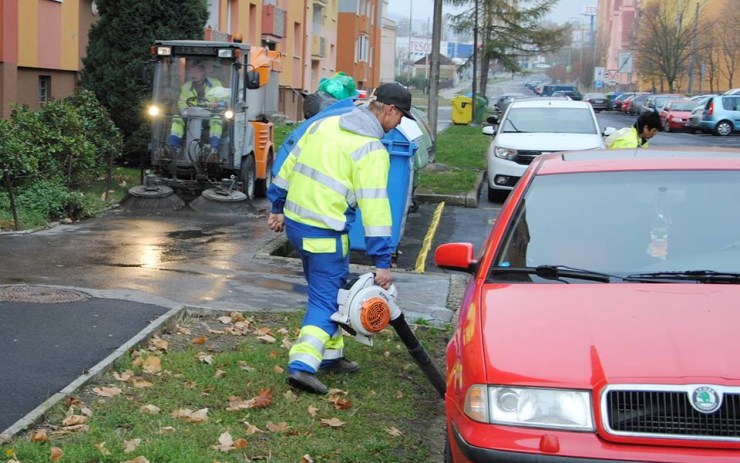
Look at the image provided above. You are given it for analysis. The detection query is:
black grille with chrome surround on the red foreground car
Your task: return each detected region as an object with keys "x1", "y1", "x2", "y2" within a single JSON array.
[{"x1": 602, "y1": 386, "x2": 740, "y2": 442}]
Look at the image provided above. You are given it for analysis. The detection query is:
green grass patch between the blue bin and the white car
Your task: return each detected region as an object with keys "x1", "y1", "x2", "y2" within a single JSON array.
[{"x1": 417, "y1": 125, "x2": 491, "y2": 194}]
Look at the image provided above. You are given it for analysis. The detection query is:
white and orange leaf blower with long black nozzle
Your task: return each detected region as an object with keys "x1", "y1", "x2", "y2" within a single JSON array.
[{"x1": 331, "y1": 273, "x2": 446, "y2": 399}]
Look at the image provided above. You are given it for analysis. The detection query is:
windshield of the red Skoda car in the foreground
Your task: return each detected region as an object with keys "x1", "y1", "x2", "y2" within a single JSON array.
[{"x1": 492, "y1": 170, "x2": 740, "y2": 281}]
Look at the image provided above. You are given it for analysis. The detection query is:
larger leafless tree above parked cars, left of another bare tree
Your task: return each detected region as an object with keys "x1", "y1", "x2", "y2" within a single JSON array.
[{"x1": 637, "y1": 0, "x2": 706, "y2": 92}]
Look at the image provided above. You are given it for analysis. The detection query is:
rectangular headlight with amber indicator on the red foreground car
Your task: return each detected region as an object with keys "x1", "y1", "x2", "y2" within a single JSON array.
[{"x1": 465, "y1": 384, "x2": 594, "y2": 431}]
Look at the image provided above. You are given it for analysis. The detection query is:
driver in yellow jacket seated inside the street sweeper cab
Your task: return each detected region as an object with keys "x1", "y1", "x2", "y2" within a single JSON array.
[{"x1": 168, "y1": 61, "x2": 223, "y2": 154}]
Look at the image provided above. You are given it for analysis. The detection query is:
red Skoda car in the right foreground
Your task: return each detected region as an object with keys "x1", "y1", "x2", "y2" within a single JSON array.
[{"x1": 435, "y1": 148, "x2": 740, "y2": 463}]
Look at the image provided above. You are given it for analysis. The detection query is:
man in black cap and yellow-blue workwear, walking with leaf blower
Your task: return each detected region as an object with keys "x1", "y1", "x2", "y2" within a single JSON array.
[{"x1": 267, "y1": 83, "x2": 413, "y2": 394}]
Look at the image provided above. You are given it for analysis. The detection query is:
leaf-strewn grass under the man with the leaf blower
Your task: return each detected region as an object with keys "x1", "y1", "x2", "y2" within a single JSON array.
[{"x1": 0, "y1": 312, "x2": 450, "y2": 463}]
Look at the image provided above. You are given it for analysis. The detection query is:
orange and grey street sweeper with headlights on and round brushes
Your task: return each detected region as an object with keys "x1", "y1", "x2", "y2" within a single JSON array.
[{"x1": 122, "y1": 35, "x2": 280, "y2": 210}]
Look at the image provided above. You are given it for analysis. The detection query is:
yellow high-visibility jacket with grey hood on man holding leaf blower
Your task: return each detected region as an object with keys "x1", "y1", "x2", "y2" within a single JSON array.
[{"x1": 268, "y1": 106, "x2": 392, "y2": 268}]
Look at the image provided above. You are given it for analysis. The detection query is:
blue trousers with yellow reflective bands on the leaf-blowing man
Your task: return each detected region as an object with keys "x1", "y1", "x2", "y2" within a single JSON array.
[{"x1": 285, "y1": 218, "x2": 349, "y2": 373}]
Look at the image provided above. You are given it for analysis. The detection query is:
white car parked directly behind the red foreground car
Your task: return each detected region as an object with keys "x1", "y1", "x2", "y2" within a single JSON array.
[{"x1": 483, "y1": 98, "x2": 613, "y2": 201}]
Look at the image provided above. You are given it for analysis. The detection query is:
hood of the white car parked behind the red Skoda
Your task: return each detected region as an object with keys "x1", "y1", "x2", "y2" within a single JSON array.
[{"x1": 494, "y1": 133, "x2": 604, "y2": 151}]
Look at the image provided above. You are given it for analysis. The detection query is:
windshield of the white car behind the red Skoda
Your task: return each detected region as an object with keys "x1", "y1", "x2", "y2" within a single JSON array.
[{"x1": 501, "y1": 107, "x2": 599, "y2": 135}]
